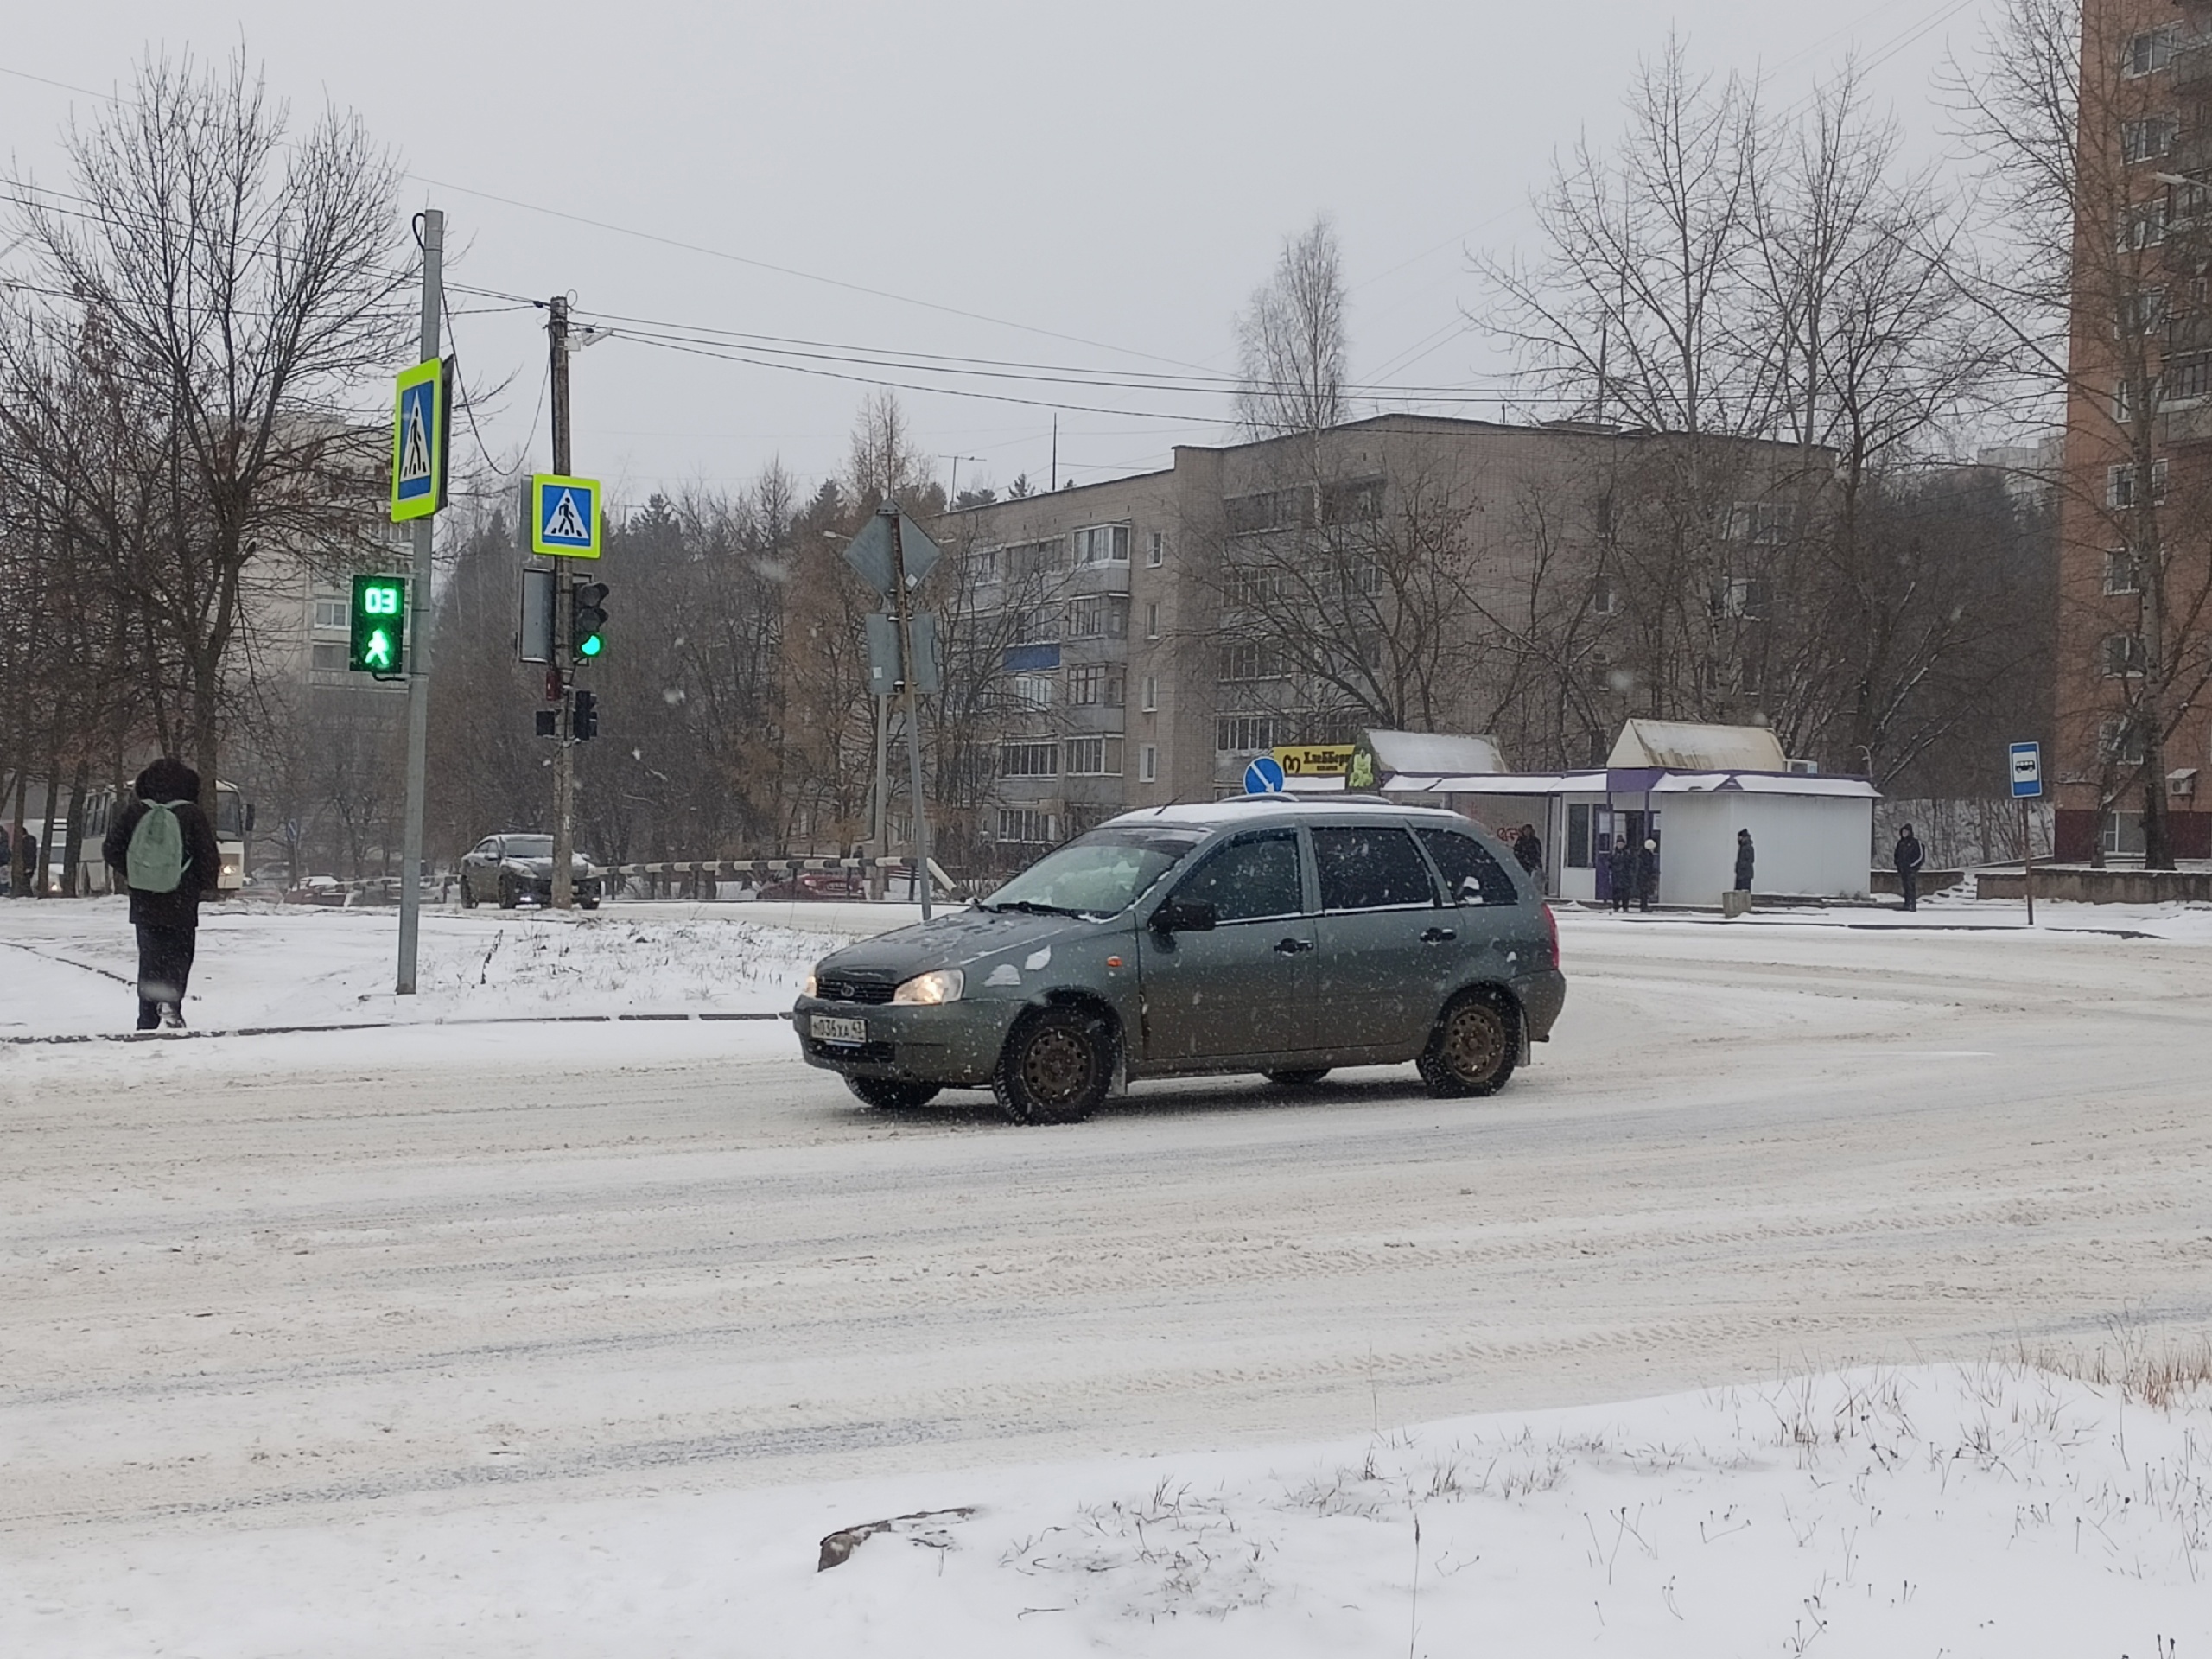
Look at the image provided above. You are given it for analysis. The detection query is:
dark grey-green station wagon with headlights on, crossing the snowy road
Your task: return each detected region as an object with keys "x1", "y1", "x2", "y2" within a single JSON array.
[{"x1": 791, "y1": 797, "x2": 1566, "y2": 1123}]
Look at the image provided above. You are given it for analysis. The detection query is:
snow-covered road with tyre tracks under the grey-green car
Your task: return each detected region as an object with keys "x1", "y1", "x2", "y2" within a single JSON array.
[{"x1": 0, "y1": 902, "x2": 2212, "y2": 1654}]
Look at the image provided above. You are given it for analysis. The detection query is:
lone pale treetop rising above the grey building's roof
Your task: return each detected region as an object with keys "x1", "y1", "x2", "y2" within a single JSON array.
[{"x1": 1236, "y1": 214, "x2": 1344, "y2": 438}]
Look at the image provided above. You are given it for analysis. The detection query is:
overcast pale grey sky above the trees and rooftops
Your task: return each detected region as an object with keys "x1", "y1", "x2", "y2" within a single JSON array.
[{"x1": 0, "y1": 0, "x2": 1995, "y2": 500}]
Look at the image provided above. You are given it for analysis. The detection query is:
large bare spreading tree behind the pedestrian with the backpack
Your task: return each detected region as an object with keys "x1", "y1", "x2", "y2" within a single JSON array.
[{"x1": 5, "y1": 53, "x2": 411, "y2": 823}]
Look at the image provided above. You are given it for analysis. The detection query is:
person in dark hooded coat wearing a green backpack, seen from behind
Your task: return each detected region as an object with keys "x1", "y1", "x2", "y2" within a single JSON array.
[{"x1": 99, "y1": 757, "x2": 224, "y2": 1031}]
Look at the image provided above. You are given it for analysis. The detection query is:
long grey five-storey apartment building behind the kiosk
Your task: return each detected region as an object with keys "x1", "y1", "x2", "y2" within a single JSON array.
[{"x1": 936, "y1": 416, "x2": 1805, "y2": 862}]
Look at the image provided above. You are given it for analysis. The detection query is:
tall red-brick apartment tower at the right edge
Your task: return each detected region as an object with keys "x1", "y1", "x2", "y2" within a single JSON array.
[{"x1": 2046, "y1": 0, "x2": 2212, "y2": 858}]
